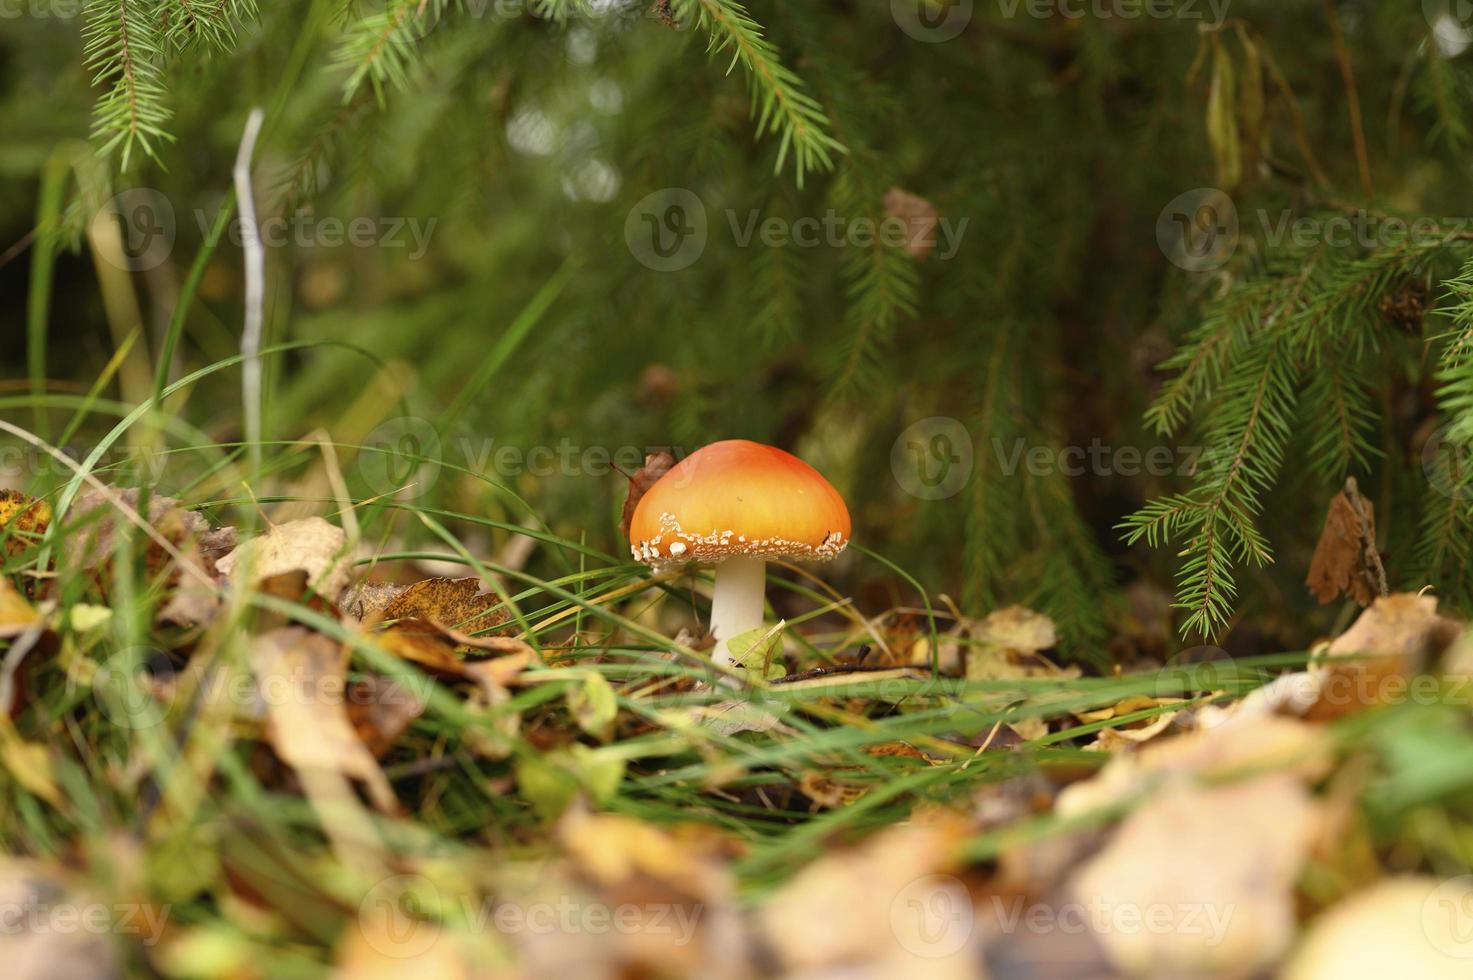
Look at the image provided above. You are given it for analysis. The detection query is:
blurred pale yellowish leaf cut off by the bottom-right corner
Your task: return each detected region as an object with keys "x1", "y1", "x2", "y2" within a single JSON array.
[{"x1": 1282, "y1": 875, "x2": 1473, "y2": 980}]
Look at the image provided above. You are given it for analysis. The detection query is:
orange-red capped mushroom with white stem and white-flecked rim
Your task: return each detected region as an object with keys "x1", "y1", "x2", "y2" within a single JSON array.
[{"x1": 629, "y1": 439, "x2": 850, "y2": 666}]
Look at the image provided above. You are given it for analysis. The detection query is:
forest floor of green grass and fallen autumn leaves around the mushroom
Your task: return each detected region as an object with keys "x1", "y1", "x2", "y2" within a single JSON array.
[{"x1": 0, "y1": 445, "x2": 1473, "y2": 980}]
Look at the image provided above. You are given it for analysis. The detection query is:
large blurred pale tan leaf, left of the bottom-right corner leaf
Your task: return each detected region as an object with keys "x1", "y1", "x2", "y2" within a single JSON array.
[{"x1": 1066, "y1": 774, "x2": 1318, "y2": 980}]
